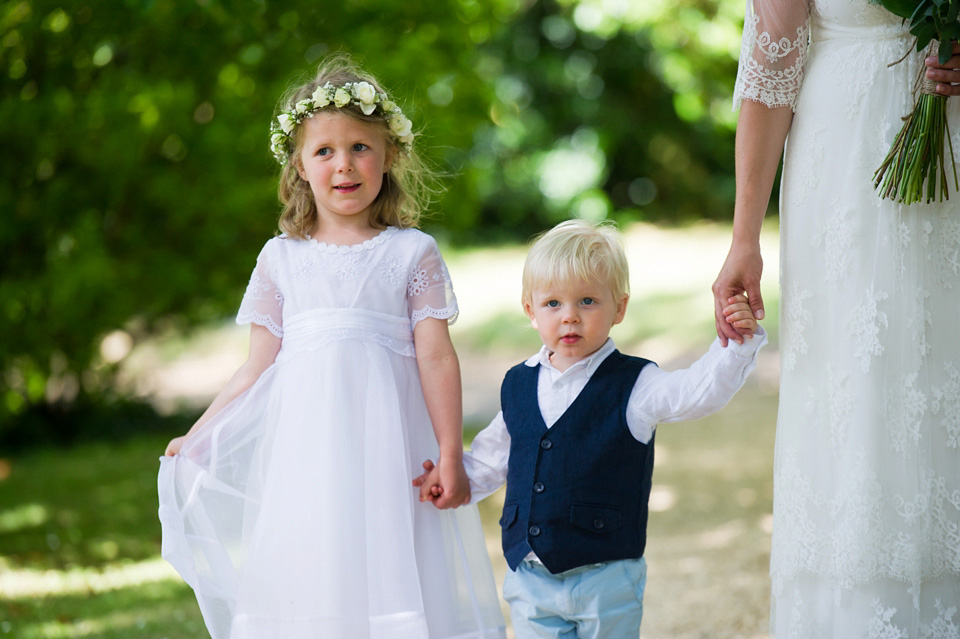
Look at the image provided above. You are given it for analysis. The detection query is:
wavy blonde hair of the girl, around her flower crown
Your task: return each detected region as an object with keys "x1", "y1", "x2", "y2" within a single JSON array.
[{"x1": 274, "y1": 53, "x2": 441, "y2": 239}]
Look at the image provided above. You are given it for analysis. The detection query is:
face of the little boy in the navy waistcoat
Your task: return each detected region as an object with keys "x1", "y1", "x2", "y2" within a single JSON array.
[{"x1": 523, "y1": 281, "x2": 627, "y2": 371}]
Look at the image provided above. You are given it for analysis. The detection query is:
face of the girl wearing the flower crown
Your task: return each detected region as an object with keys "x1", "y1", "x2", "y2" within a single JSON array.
[{"x1": 297, "y1": 111, "x2": 394, "y2": 228}]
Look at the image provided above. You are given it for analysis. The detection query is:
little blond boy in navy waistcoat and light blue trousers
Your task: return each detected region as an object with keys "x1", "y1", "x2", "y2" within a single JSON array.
[{"x1": 414, "y1": 220, "x2": 766, "y2": 639}]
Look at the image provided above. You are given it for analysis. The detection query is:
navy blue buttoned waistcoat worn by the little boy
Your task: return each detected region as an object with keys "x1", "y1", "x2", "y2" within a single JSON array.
[{"x1": 500, "y1": 351, "x2": 653, "y2": 574}]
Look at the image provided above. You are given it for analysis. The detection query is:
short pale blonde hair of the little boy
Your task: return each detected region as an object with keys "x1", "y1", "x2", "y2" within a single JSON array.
[{"x1": 521, "y1": 220, "x2": 630, "y2": 304}]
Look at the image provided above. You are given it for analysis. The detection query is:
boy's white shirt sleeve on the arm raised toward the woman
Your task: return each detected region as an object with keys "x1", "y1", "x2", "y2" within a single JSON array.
[{"x1": 627, "y1": 326, "x2": 767, "y2": 442}]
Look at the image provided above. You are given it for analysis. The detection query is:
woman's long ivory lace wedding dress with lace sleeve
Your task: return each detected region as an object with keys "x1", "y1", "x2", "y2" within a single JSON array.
[{"x1": 735, "y1": 0, "x2": 960, "y2": 639}]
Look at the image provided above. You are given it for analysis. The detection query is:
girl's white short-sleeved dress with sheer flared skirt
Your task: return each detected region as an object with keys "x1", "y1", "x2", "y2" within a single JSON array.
[{"x1": 159, "y1": 227, "x2": 504, "y2": 639}]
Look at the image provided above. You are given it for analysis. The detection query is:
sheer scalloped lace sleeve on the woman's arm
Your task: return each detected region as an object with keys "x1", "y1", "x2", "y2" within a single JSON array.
[{"x1": 733, "y1": 0, "x2": 810, "y2": 110}]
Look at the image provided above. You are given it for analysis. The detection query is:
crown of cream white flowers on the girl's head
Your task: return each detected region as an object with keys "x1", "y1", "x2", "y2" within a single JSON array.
[{"x1": 270, "y1": 82, "x2": 413, "y2": 166}]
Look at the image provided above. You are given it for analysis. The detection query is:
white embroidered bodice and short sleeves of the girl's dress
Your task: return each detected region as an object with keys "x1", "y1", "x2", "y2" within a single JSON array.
[{"x1": 237, "y1": 227, "x2": 457, "y2": 355}]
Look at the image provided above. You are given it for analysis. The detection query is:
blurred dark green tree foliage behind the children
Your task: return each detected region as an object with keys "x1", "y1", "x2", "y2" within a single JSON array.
[{"x1": 0, "y1": 0, "x2": 742, "y2": 437}]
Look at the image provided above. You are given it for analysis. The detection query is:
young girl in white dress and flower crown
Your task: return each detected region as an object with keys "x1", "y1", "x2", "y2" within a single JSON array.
[{"x1": 159, "y1": 56, "x2": 504, "y2": 639}]
